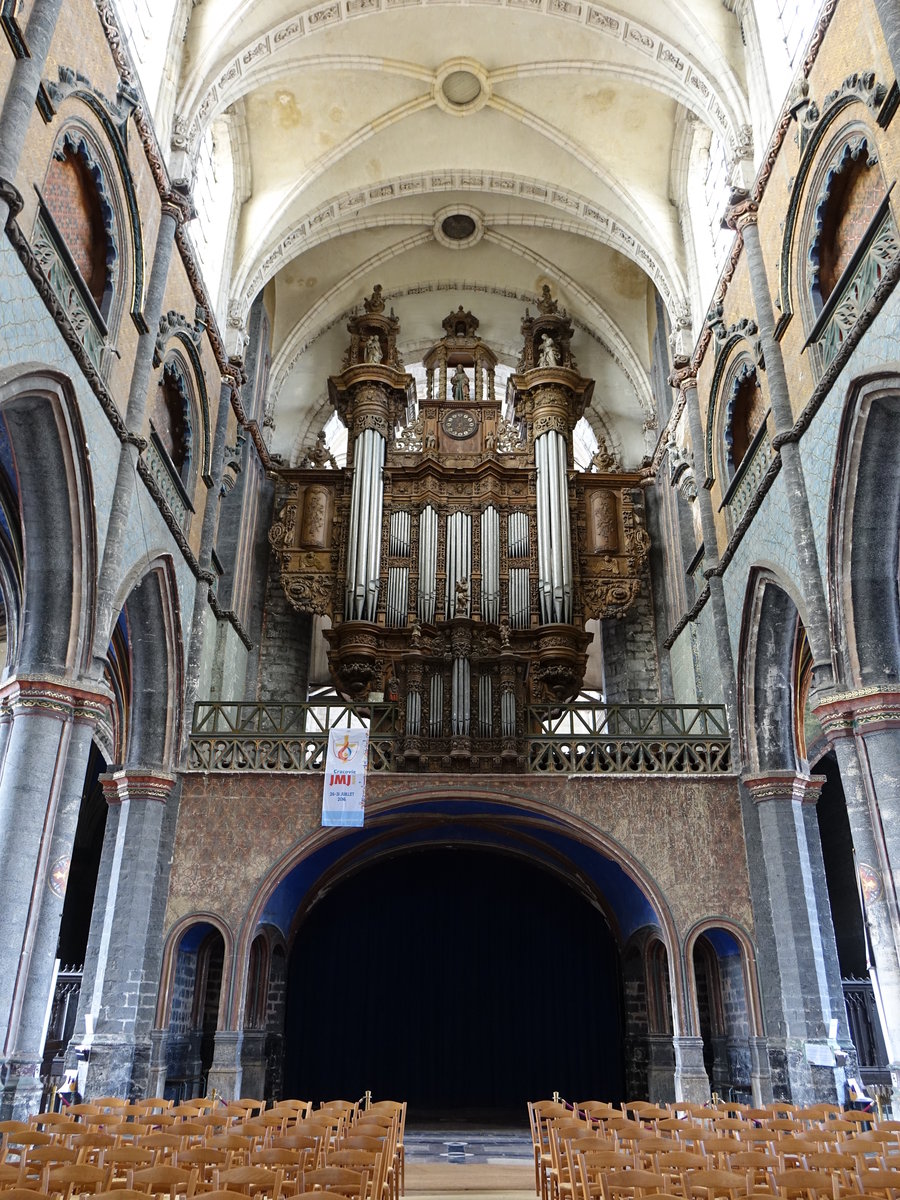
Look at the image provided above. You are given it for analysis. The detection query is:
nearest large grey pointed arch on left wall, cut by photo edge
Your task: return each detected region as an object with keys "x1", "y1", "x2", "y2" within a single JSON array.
[{"x1": 0, "y1": 365, "x2": 96, "y2": 676}]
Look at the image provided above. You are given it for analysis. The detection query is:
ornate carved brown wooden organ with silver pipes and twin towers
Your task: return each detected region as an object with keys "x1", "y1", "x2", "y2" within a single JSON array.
[{"x1": 269, "y1": 288, "x2": 648, "y2": 770}]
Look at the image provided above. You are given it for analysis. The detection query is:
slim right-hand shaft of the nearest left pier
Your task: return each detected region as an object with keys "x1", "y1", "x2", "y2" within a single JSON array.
[{"x1": 1, "y1": 695, "x2": 109, "y2": 1120}]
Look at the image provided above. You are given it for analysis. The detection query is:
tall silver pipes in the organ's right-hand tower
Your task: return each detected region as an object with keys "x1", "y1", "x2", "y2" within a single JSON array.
[{"x1": 534, "y1": 430, "x2": 572, "y2": 624}]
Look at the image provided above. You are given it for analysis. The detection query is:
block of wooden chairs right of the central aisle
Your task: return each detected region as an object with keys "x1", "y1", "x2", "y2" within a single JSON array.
[{"x1": 528, "y1": 1100, "x2": 900, "y2": 1200}]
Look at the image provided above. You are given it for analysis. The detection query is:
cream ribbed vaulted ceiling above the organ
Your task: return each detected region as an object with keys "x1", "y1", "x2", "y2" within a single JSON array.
[{"x1": 175, "y1": 0, "x2": 750, "y2": 467}]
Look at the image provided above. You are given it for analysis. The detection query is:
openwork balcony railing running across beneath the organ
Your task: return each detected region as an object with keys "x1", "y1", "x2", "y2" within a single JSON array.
[{"x1": 188, "y1": 700, "x2": 731, "y2": 775}]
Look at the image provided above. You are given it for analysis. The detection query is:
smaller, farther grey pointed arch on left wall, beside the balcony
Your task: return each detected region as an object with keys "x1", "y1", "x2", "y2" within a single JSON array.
[{"x1": 114, "y1": 557, "x2": 184, "y2": 767}]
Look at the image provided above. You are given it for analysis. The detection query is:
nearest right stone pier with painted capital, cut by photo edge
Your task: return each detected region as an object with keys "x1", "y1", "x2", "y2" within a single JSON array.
[{"x1": 814, "y1": 689, "x2": 900, "y2": 1090}]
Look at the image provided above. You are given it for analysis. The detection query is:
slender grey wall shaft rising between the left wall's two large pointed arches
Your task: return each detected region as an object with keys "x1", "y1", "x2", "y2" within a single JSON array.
[{"x1": 94, "y1": 192, "x2": 190, "y2": 677}]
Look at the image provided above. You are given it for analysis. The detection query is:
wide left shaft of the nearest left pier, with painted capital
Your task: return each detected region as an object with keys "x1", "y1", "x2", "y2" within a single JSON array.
[{"x1": 0, "y1": 676, "x2": 99, "y2": 1084}]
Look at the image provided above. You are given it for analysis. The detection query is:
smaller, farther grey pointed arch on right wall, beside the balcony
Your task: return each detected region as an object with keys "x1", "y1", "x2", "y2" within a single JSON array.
[{"x1": 739, "y1": 569, "x2": 802, "y2": 770}]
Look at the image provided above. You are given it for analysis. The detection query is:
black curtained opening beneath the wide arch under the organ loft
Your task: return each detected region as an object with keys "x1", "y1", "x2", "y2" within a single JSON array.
[{"x1": 284, "y1": 847, "x2": 623, "y2": 1117}]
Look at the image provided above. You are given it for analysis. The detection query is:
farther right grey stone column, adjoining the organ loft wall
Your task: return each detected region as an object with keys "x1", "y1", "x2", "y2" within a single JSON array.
[{"x1": 744, "y1": 770, "x2": 846, "y2": 1104}]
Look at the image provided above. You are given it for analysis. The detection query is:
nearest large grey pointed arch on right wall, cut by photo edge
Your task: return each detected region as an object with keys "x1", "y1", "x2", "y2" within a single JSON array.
[{"x1": 828, "y1": 364, "x2": 900, "y2": 688}]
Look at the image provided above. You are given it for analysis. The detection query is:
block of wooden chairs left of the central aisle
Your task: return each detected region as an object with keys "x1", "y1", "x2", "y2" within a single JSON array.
[{"x1": 0, "y1": 1097, "x2": 406, "y2": 1200}]
